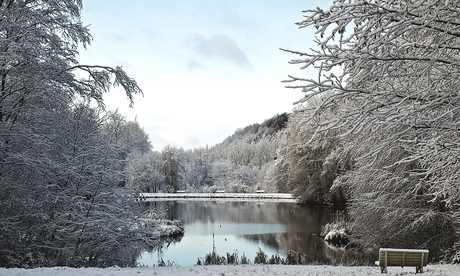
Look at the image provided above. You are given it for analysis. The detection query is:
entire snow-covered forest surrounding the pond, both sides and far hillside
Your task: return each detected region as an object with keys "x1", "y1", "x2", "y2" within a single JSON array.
[{"x1": 0, "y1": 0, "x2": 460, "y2": 267}]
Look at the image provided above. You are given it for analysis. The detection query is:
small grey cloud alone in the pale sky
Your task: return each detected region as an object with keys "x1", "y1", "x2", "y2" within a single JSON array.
[{"x1": 187, "y1": 34, "x2": 252, "y2": 69}]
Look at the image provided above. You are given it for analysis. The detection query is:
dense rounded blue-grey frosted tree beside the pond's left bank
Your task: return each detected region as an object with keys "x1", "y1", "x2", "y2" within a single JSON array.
[{"x1": 0, "y1": 102, "x2": 165, "y2": 267}]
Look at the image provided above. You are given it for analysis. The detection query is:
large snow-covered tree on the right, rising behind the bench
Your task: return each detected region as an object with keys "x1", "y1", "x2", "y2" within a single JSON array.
[{"x1": 288, "y1": 0, "x2": 460, "y2": 256}]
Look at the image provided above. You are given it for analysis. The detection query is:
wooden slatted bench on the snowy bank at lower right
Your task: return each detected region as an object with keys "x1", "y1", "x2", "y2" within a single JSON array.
[{"x1": 379, "y1": 248, "x2": 429, "y2": 273}]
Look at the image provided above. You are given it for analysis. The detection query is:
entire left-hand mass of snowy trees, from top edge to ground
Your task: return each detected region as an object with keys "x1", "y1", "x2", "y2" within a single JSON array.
[{"x1": 0, "y1": 0, "x2": 178, "y2": 267}]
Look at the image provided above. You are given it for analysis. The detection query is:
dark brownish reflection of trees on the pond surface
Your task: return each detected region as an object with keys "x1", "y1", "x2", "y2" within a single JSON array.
[{"x1": 139, "y1": 201, "x2": 374, "y2": 263}]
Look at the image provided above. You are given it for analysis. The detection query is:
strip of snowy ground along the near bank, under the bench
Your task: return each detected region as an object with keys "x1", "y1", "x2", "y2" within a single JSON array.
[{"x1": 0, "y1": 265, "x2": 460, "y2": 276}]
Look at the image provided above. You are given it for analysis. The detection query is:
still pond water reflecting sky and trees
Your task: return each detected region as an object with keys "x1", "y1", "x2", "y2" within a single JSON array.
[{"x1": 138, "y1": 200, "x2": 342, "y2": 267}]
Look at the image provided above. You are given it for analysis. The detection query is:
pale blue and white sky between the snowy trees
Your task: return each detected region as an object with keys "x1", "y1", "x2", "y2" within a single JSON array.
[{"x1": 78, "y1": 0, "x2": 332, "y2": 151}]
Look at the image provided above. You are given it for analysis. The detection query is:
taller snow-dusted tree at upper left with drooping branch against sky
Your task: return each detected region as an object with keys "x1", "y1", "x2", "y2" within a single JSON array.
[{"x1": 0, "y1": 0, "x2": 142, "y2": 129}]
